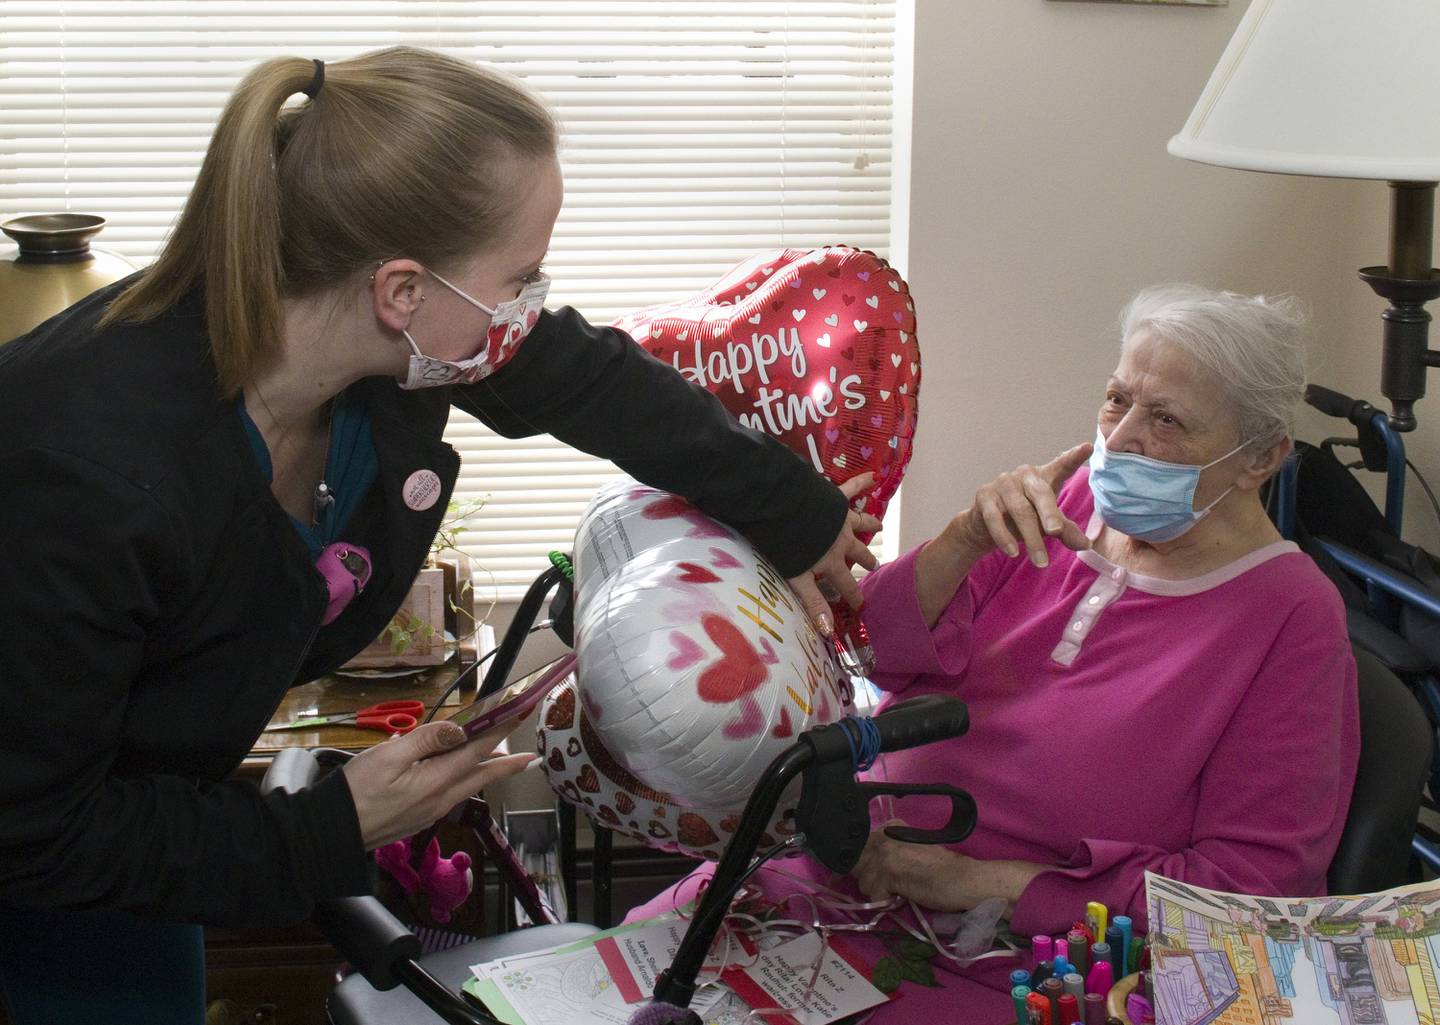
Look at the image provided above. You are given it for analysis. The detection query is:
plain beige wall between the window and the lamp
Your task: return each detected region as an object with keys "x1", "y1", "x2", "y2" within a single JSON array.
[{"x1": 897, "y1": 0, "x2": 1440, "y2": 547}]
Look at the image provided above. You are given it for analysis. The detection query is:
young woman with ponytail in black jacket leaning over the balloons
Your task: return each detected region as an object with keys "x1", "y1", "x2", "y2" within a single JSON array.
[{"x1": 0, "y1": 49, "x2": 877, "y2": 1025}]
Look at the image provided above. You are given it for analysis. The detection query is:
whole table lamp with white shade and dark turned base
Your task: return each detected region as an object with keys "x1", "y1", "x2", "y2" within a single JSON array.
[{"x1": 1168, "y1": 0, "x2": 1440, "y2": 430}]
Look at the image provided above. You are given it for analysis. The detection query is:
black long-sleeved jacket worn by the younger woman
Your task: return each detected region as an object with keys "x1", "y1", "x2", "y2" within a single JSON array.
[{"x1": 0, "y1": 282, "x2": 845, "y2": 926}]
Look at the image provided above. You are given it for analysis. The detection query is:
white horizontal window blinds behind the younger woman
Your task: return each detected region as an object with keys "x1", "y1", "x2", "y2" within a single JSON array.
[{"x1": 0, "y1": 0, "x2": 896, "y2": 595}]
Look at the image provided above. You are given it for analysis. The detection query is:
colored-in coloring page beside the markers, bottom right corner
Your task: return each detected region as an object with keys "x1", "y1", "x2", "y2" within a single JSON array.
[{"x1": 1145, "y1": 872, "x2": 1440, "y2": 1025}]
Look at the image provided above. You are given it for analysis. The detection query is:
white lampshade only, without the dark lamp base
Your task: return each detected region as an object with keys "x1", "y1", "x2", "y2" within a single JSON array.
[{"x1": 1169, "y1": 0, "x2": 1440, "y2": 181}]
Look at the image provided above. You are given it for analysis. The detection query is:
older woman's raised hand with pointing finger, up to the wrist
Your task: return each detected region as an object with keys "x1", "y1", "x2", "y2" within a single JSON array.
[{"x1": 946, "y1": 442, "x2": 1094, "y2": 566}]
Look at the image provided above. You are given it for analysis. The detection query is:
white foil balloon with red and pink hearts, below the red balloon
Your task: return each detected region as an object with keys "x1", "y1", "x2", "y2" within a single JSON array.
[{"x1": 541, "y1": 479, "x2": 850, "y2": 852}]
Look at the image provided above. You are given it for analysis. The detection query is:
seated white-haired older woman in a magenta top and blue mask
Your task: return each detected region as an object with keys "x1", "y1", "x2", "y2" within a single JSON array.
[{"x1": 635, "y1": 285, "x2": 1359, "y2": 1022}]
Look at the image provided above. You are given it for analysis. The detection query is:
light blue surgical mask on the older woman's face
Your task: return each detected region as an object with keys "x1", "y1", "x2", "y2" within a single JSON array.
[{"x1": 1090, "y1": 430, "x2": 1248, "y2": 541}]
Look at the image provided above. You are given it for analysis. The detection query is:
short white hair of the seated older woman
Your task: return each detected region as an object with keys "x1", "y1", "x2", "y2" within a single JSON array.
[{"x1": 1120, "y1": 285, "x2": 1305, "y2": 449}]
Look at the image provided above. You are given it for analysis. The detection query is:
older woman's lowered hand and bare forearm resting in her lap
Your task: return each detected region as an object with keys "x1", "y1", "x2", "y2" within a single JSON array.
[{"x1": 854, "y1": 819, "x2": 1047, "y2": 914}]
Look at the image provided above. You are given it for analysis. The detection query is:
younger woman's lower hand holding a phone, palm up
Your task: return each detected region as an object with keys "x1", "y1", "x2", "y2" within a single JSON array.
[{"x1": 344, "y1": 723, "x2": 539, "y2": 851}]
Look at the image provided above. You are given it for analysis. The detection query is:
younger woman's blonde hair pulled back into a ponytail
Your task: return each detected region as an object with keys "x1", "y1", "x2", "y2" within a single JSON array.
[{"x1": 101, "y1": 48, "x2": 556, "y2": 396}]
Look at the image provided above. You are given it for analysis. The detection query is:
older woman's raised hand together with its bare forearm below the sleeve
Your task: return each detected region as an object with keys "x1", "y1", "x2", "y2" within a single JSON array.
[{"x1": 916, "y1": 442, "x2": 1093, "y2": 626}]
